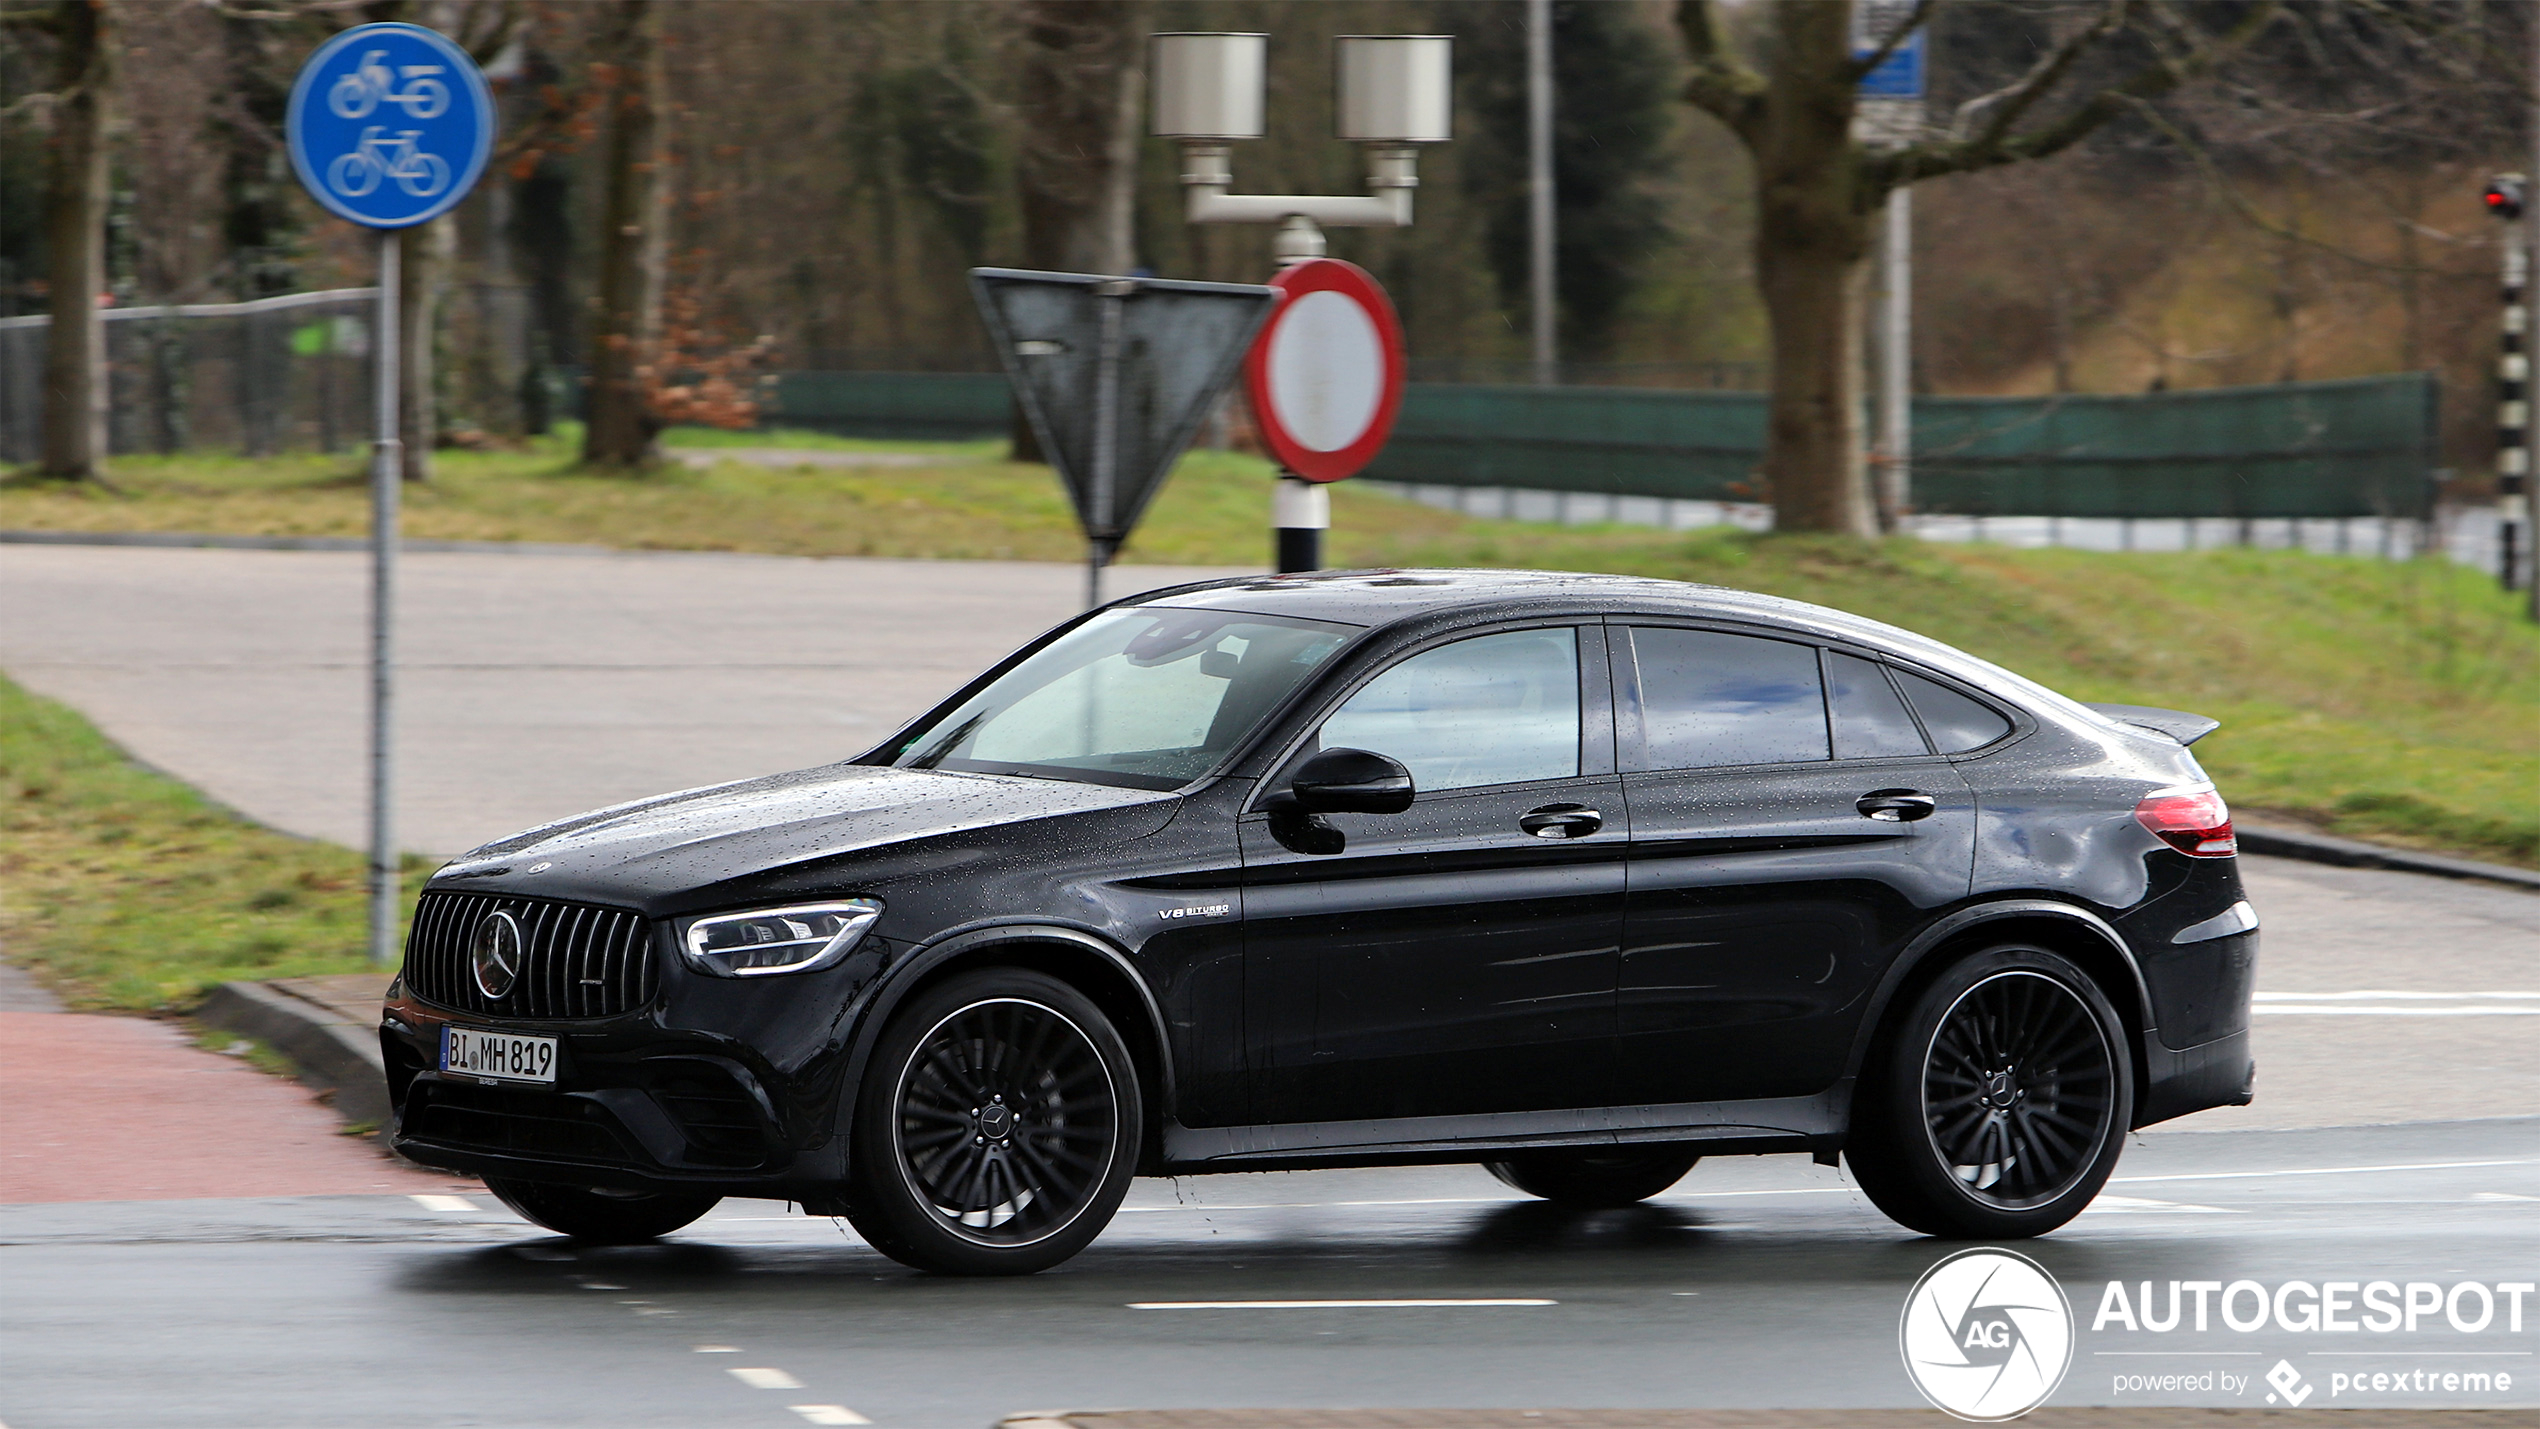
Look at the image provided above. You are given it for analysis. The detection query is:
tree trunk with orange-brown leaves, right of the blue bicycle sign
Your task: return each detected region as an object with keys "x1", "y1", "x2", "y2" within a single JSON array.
[{"x1": 582, "y1": 0, "x2": 668, "y2": 467}]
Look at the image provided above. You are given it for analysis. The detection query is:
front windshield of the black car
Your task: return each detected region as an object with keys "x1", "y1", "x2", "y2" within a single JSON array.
[{"x1": 892, "y1": 607, "x2": 1359, "y2": 789}]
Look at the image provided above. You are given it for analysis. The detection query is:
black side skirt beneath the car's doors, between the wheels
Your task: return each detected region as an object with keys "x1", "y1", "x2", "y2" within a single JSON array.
[{"x1": 1158, "y1": 1079, "x2": 1852, "y2": 1175}]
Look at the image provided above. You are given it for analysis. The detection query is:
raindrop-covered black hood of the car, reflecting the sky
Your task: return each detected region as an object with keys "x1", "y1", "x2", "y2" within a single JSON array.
[{"x1": 432, "y1": 764, "x2": 1179, "y2": 904}]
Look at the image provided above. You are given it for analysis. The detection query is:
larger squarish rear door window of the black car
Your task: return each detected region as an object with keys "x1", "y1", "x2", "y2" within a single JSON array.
[{"x1": 1631, "y1": 627, "x2": 1829, "y2": 769}]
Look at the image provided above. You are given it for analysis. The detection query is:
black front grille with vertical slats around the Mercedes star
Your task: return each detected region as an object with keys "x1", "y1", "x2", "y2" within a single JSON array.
[{"x1": 406, "y1": 893, "x2": 655, "y2": 1018}]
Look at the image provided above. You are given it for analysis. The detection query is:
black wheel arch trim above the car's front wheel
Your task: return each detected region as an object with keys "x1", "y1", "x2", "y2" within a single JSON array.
[{"x1": 838, "y1": 924, "x2": 1173, "y2": 1165}]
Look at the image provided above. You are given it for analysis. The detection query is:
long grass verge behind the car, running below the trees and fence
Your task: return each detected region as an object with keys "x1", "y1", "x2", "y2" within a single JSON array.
[{"x1": 0, "y1": 429, "x2": 2540, "y2": 866}]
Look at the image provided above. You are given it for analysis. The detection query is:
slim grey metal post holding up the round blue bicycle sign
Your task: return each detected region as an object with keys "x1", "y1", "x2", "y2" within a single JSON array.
[{"x1": 371, "y1": 228, "x2": 406, "y2": 967}]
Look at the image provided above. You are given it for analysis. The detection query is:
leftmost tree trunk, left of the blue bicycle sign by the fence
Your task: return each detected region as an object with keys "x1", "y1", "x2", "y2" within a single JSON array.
[{"x1": 43, "y1": 0, "x2": 114, "y2": 480}]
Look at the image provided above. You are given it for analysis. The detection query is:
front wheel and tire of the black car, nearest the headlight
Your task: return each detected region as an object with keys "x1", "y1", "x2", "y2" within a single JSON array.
[{"x1": 848, "y1": 967, "x2": 1146, "y2": 1274}]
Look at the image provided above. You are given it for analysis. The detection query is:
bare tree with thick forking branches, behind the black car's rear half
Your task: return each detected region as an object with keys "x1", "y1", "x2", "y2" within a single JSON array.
[{"x1": 1676, "y1": 0, "x2": 2276, "y2": 536}]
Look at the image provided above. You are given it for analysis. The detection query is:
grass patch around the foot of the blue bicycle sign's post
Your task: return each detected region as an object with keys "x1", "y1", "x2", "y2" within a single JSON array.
[{"x1": 0, "y1": 678, "x2": 427, "y2": 1010}]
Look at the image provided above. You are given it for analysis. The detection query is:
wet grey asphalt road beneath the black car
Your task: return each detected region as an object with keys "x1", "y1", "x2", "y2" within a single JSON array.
[{"x1": 0, "y1": 1117, "x2": 2540, "y2": 1429}]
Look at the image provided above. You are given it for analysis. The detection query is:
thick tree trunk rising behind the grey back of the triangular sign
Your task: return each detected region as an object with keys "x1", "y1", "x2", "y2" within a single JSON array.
[{"x1": 1013, "y1": 0, "x2": 1148, "y2": 462}]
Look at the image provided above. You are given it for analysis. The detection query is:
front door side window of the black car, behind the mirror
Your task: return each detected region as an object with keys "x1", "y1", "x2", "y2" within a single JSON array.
[{"x1": 1321, "y1": 627, "x2": 1580, "y2": 792}]
